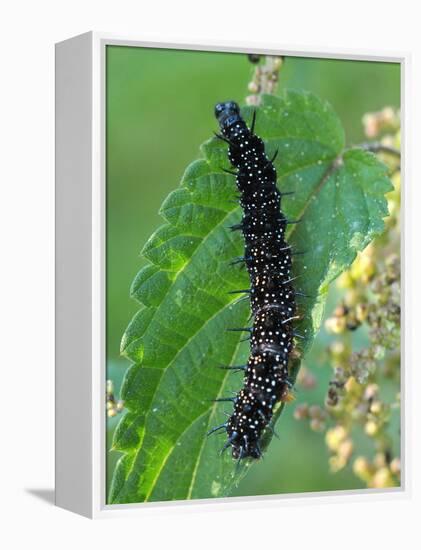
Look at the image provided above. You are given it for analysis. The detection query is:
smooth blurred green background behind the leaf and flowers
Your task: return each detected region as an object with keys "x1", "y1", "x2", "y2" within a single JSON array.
[{"x1": 106, "y1": 46, "x2": 400, "y2": 496}]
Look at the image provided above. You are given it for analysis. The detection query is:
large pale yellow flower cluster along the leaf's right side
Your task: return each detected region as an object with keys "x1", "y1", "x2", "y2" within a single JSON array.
[{"x1": 294, "y1": 107, "x2": 401, "y2": 488}]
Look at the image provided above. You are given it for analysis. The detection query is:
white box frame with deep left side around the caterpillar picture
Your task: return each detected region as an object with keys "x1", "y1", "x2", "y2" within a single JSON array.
[{"x1": 56, "y1": 32, "x2": 410, "y2": 518}]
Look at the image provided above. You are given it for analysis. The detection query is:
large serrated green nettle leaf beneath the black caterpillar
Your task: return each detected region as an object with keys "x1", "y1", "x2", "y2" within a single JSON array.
[{"x1": 109, "y1": 91, "x2": 392, "y2": 503}]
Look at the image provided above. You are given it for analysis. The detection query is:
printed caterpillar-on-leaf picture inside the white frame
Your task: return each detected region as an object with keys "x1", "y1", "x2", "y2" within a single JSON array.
[{"x1": 104, "y1": 46, "x2": 401, "y2": 504}]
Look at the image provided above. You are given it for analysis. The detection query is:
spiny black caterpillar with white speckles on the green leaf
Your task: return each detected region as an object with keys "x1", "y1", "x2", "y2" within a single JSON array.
[{"x1": 209, "y1": 101, "x2": 298, "y2": 460}]
